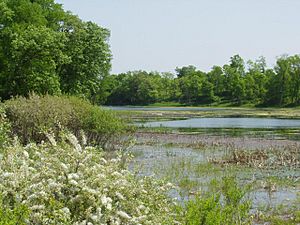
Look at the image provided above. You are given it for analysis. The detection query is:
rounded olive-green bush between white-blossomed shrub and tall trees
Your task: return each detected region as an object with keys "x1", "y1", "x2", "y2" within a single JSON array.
[{"x1": 5, "y1": 94, "x2": 127, "y2": 148}]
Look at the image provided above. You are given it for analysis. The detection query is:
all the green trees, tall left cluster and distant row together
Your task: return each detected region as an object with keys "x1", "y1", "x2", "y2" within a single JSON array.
[{"x1": 0, "y1": 0, "x2": 300, "y2": 106}]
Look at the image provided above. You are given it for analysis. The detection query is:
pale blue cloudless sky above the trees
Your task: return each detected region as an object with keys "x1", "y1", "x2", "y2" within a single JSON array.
[{"x1": 56, "y1": 0, "x2": 300, "y2": 73}]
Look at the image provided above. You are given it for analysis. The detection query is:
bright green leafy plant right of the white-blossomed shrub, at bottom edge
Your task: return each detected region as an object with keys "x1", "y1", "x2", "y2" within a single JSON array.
[{"x1": 181, "y1": 177, "x2": 250, "y2": 225}]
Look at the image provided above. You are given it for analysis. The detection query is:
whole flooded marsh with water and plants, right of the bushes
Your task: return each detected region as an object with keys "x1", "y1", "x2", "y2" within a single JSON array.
[{"x1": 115, "y1": 108, "x2": 300, "y2": 224}]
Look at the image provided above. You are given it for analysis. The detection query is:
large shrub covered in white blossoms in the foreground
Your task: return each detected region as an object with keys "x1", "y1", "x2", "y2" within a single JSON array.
[{"x1": 0, "y1": 134, "x2": 174, "y2": 225}]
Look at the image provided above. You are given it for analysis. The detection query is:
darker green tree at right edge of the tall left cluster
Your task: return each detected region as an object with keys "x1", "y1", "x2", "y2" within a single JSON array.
[{"x1": 59, "y1": 16, "x2": 111, "y2": 102}]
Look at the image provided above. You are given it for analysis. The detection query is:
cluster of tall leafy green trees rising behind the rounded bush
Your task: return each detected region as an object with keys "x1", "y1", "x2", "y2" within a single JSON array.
[{"x1": 0, "y1": 0, "x2": 111, "y2": 102}]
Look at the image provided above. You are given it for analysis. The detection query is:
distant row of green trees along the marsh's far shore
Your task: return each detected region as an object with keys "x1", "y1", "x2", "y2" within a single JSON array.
[{"x1": 102, "y1": 55, "x2": 300, "y2": 106}]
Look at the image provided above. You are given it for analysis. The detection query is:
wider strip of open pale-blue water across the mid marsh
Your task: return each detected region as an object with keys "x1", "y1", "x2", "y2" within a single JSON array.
[{"x1": 139, "y1": 118, "x2": 300, "y2": 129}]
